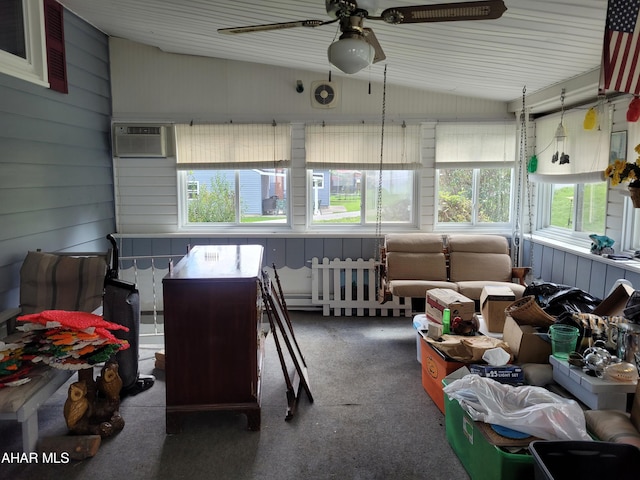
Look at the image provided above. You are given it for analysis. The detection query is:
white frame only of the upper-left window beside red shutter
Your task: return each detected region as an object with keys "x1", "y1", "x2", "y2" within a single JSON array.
[{"x1": 0, "y1": 0, "x2": 50, "y2": 88}]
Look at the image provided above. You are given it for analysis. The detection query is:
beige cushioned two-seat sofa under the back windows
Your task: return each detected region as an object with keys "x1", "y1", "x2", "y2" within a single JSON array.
[{"x1": 380, "y1": 233, "x2": 528, "y2": 301}]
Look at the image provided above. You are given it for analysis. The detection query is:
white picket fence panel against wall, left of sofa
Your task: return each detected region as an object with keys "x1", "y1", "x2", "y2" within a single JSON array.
[{"x1": 311, "y1": 257, "x2": 411, "y2": 317}]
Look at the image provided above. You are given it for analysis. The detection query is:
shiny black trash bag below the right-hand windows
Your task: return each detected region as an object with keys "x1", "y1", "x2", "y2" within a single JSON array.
[{"x1": 523, "y1": 282, "x2": 602, "y2": 317}]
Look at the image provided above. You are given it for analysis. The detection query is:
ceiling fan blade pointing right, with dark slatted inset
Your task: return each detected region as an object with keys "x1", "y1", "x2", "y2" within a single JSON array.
[{"x1": 372, "y1": 0, "x2": 507, "y2": 24}]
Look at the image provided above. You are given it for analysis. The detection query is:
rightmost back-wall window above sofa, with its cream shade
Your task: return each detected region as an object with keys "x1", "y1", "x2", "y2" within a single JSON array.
[{"x1": 436, "y1": 123, "x2": 515, "y2": 226}]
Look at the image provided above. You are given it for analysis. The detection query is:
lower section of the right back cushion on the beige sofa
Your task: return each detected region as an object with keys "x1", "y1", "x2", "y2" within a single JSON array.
[{"x1": 449, "y1": 252, "x2": 512, "y2": 282}]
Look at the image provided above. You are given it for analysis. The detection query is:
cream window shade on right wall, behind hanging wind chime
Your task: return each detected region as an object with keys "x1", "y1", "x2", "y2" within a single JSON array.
[{"x1": 530, "y1": 105, "x2": 611, "y2": 184}]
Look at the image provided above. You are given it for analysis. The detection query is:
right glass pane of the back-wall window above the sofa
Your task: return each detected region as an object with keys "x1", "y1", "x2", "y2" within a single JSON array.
[{"x1": 478, "y1": 168, "x2": 512, "y2": 223}]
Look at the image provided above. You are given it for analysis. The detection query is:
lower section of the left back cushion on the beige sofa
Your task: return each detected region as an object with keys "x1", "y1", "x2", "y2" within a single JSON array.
[{"x1": 387, "y1": 251, "x2": 447, "y2": 281}]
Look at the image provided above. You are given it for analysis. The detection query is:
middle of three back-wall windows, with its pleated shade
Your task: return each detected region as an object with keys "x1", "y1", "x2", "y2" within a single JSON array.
[{"x1": 305, "y1": 124, "x2": 421, "y2": 226}]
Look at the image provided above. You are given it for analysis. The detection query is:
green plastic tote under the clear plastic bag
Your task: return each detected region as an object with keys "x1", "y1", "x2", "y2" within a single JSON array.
[{"x1": 443, "y1": 369, "x2": 536, "y2": 480}]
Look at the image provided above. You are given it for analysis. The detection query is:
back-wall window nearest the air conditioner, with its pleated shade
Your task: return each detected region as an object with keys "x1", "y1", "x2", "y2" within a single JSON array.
[{"x1": 176, "y1": 124, "x2": 291, "y2": 228}]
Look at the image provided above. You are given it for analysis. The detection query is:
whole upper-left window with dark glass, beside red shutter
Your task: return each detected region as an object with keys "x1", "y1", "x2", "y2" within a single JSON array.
[{"x1": 0, "y1": 0, "x2": 48, "y2": 87}]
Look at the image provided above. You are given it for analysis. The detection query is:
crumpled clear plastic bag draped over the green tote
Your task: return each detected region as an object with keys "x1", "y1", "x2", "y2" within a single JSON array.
[{"x1": 444, "y1": 374, "x2": 592, "y2": 441}]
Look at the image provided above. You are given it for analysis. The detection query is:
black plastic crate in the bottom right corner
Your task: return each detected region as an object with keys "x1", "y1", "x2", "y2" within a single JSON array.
[{"x1": 529, "y1": 440, "x2": 640, "y2": 480}]
